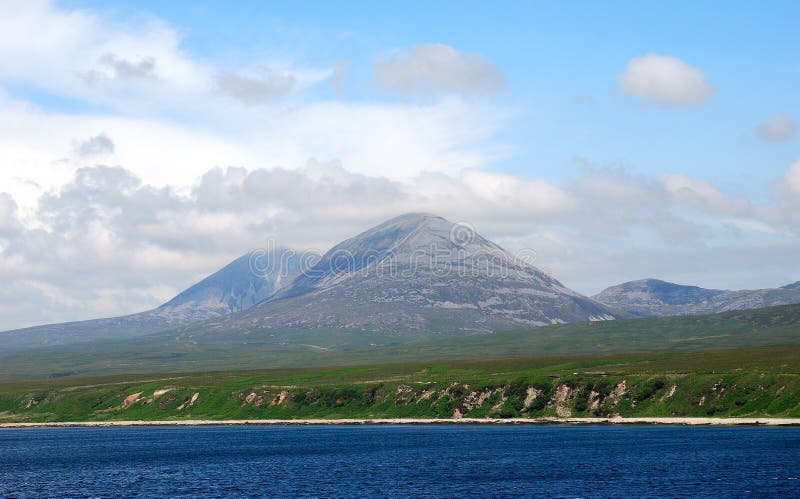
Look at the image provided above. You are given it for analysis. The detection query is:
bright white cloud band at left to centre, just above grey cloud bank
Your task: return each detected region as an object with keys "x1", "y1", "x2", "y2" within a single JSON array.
[{"x1": 0, "y1": 94, "x2": 507, "y2": 213}]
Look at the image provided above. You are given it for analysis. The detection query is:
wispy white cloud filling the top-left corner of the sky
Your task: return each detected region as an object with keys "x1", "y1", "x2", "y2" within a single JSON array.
[{"x1": 0, "y1": 0, "x2": 210, "y2": 111}]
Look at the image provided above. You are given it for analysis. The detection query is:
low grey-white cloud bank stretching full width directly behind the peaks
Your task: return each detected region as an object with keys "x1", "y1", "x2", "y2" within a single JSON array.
[{"x1": 0, "y1": 161, "x2": 800, "y2": 327}]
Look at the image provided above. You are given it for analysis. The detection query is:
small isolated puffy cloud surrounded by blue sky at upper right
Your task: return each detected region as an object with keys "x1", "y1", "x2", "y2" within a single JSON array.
[{"x1": 619, "y1": 54, "x2": 714, "y2": 106}]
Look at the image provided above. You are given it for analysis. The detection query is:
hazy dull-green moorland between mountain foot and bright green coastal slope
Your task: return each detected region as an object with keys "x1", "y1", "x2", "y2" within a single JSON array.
[{"x1": 0, "y1": 305, "x2": 800, "y2": 380}]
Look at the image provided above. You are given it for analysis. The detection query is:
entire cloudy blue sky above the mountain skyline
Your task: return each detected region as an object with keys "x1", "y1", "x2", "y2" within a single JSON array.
[{"x1": 0, "y1": 0, "x2": 800, "y2": 330}]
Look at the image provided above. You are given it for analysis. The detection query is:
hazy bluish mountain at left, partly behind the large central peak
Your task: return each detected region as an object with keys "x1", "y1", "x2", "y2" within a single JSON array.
[{"x1": 0, "y1": 248, "x2": 300, "y2": 351}]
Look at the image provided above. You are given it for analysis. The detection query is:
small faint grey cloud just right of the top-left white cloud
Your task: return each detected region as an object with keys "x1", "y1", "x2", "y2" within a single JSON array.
[{"x1": 216, "y1": 71, "x2": 297, "y2": 106}]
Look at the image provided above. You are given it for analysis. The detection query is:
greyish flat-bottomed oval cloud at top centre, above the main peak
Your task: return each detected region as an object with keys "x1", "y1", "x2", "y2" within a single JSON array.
[{"x1": 374, "y1": 43, "x2": 503, "y2": 94}]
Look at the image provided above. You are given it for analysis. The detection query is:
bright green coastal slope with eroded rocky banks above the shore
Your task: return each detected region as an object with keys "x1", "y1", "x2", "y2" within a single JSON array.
[{"x1": 0, "y1": 346, "x2": 800, "y2": 422}]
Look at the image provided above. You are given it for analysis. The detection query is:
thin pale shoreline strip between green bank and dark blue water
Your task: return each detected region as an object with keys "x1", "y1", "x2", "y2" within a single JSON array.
[{"x1": 0, "y1": 417, "x2": 800, "y2": 429}]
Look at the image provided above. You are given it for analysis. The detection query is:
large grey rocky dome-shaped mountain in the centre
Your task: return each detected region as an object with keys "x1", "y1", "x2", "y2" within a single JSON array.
[{"x1": 181, "y1": 214, "x2": 616, "y2": 338}]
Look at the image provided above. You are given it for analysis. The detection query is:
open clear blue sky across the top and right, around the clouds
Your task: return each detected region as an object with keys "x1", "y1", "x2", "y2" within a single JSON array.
[{"x1": 57, "y1": 2, "x2": 800, "y2": 191}]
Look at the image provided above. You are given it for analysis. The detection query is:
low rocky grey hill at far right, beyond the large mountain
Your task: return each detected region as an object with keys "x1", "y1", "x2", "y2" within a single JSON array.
[{"x1": 592, "y1": 279, "x2": 800, "y2": 316}]
